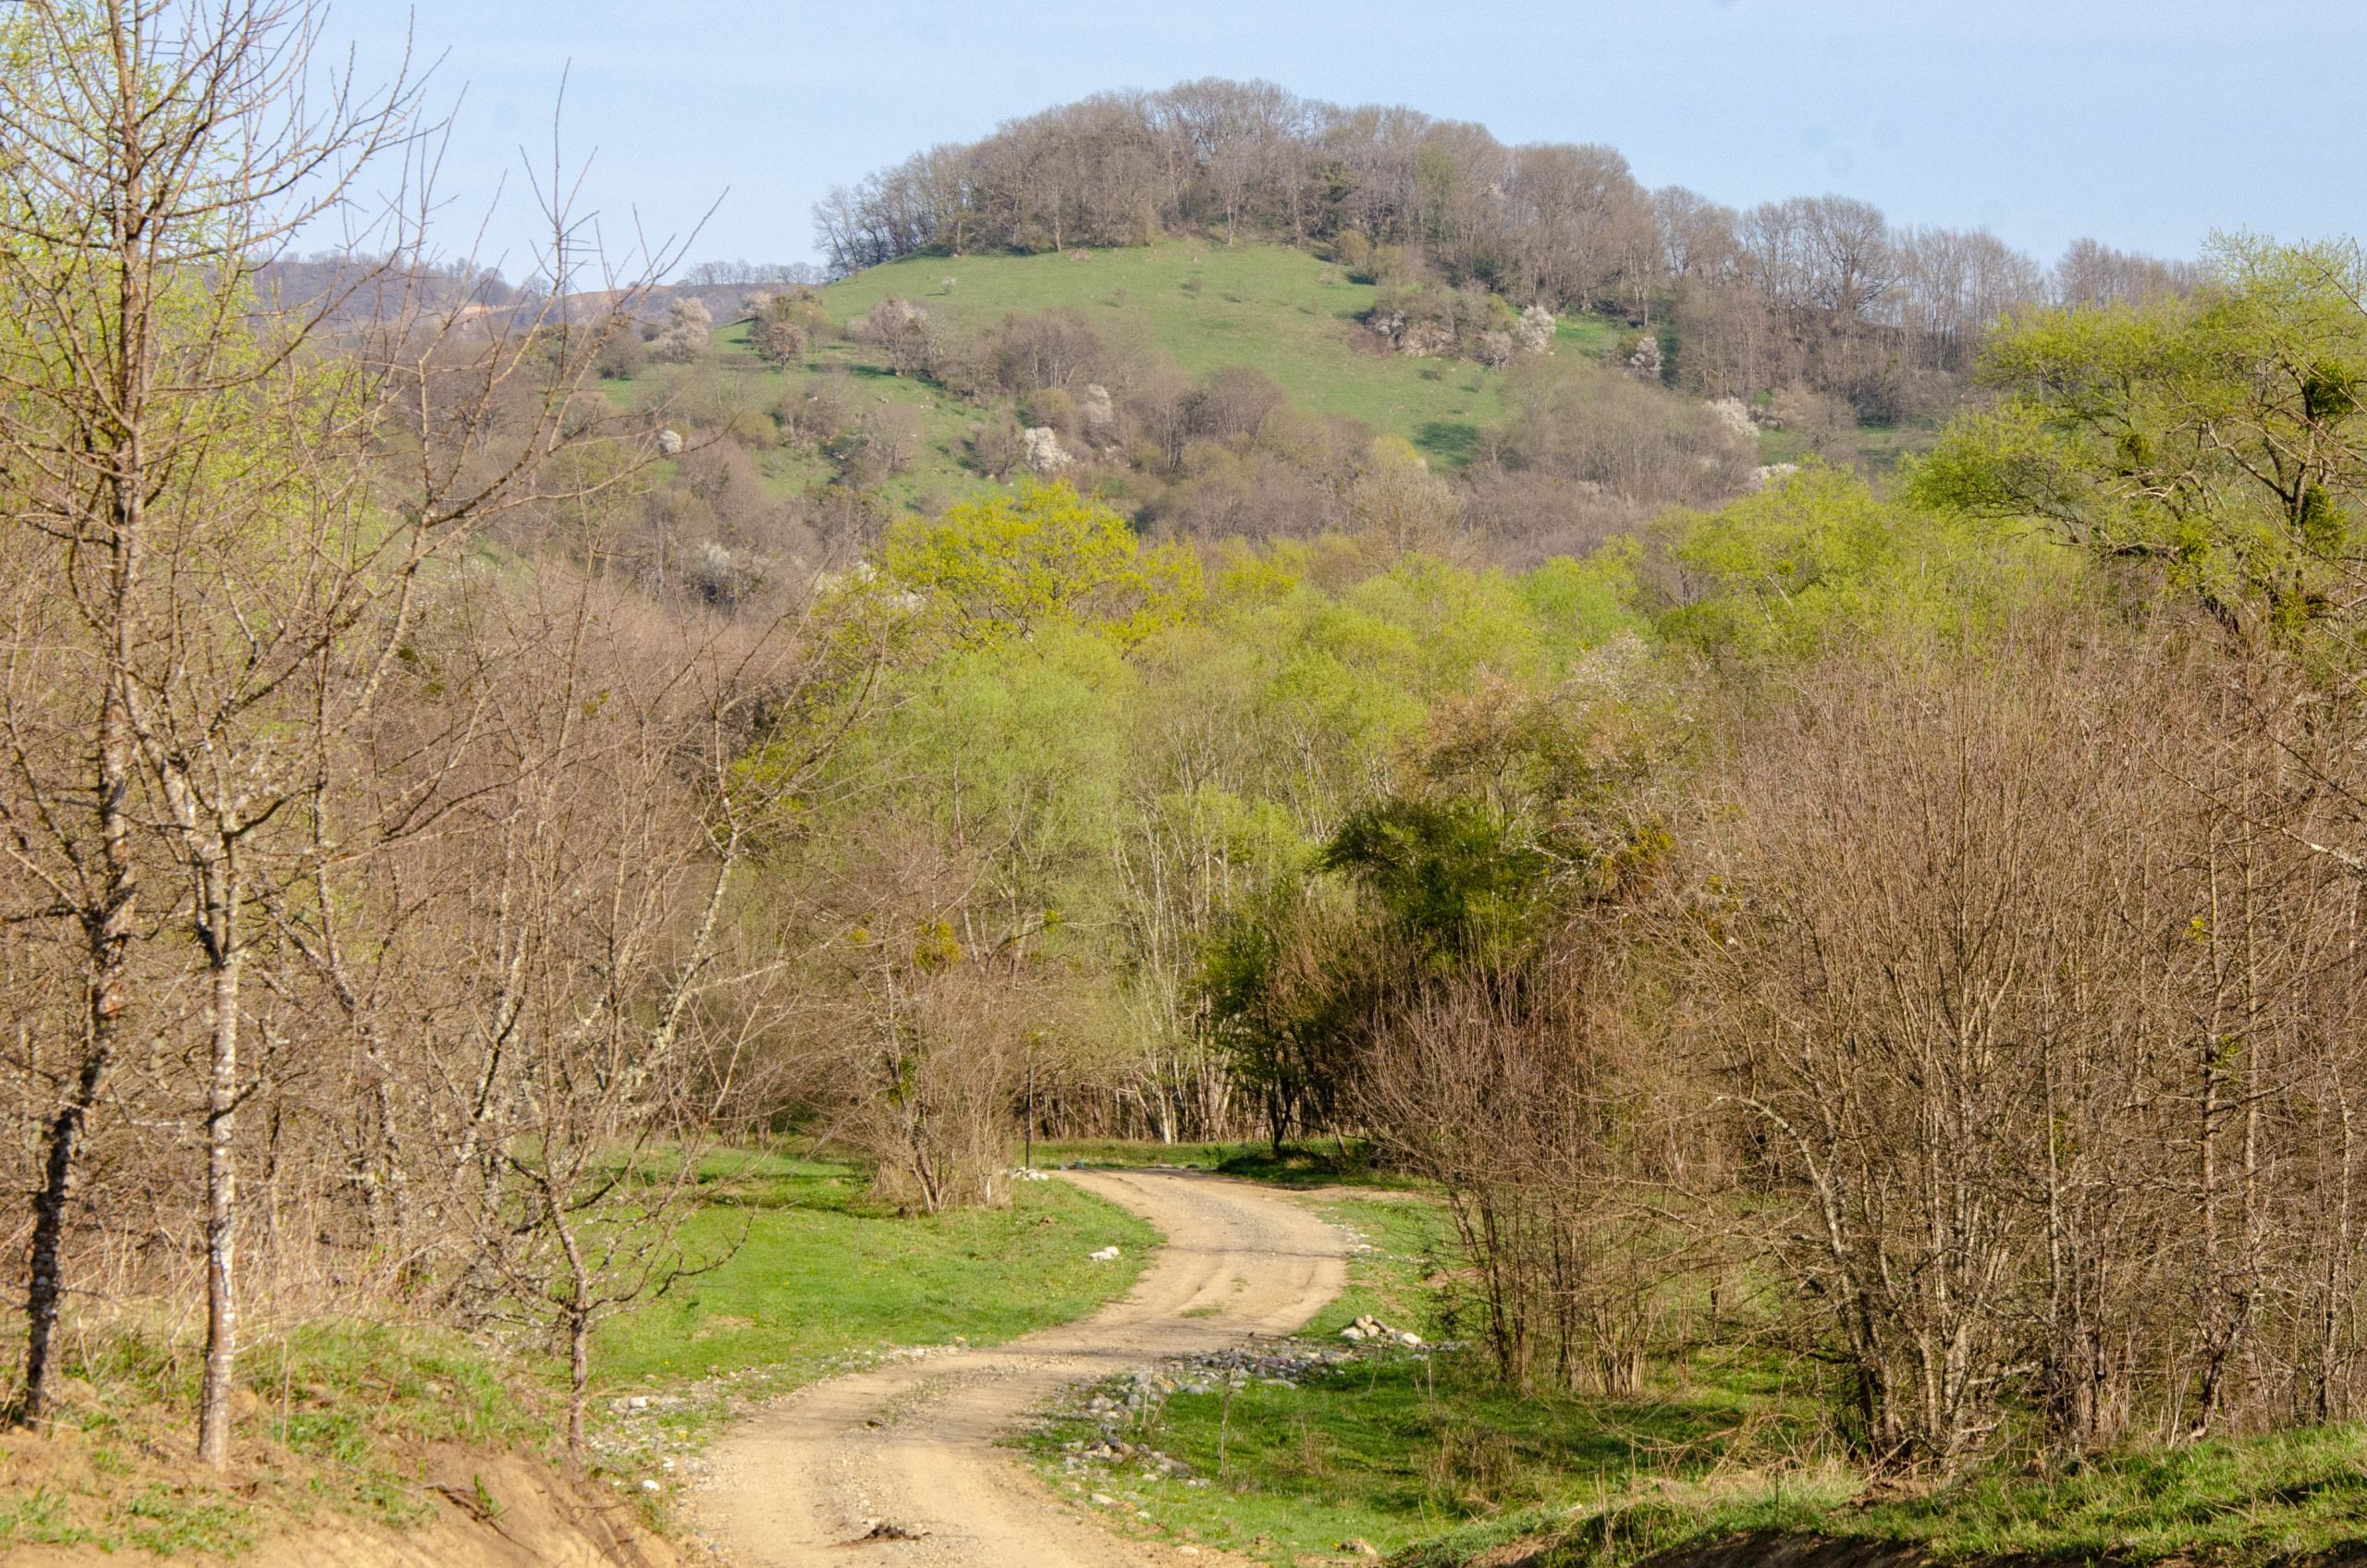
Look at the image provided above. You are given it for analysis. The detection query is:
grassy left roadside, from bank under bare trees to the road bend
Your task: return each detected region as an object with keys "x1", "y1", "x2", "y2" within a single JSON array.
[{"x1": 0, "y1": 1154, "x2": 1158, "y2": 1559}]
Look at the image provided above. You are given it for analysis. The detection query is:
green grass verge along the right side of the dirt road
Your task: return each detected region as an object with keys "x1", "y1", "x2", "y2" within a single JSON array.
[{"x1": 1024, "y1": 1183, "x2": 2367, "y2": 1568}]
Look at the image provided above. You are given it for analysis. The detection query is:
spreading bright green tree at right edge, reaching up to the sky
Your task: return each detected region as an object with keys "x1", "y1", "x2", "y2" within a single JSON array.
[{"x1": 1907, "y1": 237, "x2": 2367, "y2": 642}]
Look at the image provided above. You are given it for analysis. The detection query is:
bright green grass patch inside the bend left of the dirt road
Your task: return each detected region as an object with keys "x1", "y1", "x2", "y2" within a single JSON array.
[{"x1": 595, "y1": 1154, "x2": 1158, "y2": 1390}]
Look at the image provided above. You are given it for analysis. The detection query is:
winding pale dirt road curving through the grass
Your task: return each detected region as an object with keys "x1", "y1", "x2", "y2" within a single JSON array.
[{"x1": 698, "y1": 1170, "x2": 1344, "y2": 1568}]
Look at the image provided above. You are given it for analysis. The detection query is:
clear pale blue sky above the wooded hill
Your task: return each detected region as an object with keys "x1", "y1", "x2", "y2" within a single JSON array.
[{"x1": 329, "y1": 0, "x2": 2367, "y2": 277}]
